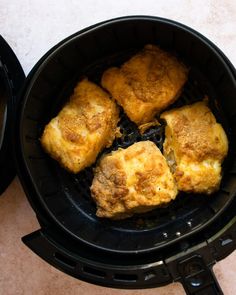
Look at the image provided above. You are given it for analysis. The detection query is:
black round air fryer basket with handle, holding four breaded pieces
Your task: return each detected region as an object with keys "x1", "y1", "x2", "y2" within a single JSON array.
[{"x1": 0, "y1": 16, "x2": 236, "y2": 294}]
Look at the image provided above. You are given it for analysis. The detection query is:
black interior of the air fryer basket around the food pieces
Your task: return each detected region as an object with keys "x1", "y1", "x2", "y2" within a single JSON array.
[{"x1": 20, "y1": 20, "x2": 236, "y2": 253}]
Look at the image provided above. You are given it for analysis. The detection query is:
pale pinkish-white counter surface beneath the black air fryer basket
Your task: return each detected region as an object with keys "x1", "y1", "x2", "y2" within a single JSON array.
[{"x1": 0, "y1": 0, "x2": 236, "y2": 295}]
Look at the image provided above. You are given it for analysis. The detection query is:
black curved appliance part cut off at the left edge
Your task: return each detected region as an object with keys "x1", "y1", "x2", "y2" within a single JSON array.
[{"x1": 0, "y1": 35, "x2": 25, "y2": 194}]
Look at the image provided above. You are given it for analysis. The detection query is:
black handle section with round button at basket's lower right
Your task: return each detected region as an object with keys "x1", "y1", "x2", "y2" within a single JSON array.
[{"x1": 165, "y1": 216, "x2": 236, "y2": 295}]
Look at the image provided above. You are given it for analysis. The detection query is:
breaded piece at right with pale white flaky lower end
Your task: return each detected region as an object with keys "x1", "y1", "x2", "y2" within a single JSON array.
[{"x1": 161, "y1": 101, "x2": 228, "y2": 194}]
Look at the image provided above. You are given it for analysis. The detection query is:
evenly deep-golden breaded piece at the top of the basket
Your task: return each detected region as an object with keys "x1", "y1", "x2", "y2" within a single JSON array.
[{"x1": 102, "y1": 45, "x2": 188, "y2": 125}]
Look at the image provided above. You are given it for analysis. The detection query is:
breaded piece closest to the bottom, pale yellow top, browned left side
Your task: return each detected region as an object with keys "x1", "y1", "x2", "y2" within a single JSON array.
[{"x1": 91, "y1": 141, "x2": 177, "y2": 219}]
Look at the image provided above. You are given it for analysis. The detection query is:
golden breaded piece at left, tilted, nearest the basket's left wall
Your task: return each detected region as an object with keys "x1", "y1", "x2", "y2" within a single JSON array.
[{"x1": 41, "y1": 79, "x2": 119, "y2": 173}]
